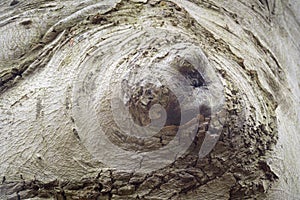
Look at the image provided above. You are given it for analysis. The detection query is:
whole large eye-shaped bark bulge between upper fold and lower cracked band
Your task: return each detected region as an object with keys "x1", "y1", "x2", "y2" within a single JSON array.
[{"x1": 0, "y1": 1, "x2": 282, "y2": 198}]
